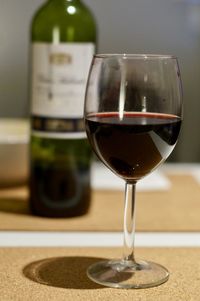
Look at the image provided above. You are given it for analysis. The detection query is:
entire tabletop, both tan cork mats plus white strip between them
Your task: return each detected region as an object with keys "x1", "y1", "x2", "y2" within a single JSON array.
[{"x1": 0, "y1": 164, "x2": 200, "y2": 301}]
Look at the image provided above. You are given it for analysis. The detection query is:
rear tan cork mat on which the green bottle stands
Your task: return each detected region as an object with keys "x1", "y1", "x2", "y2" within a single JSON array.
[{"x1": 0, "y1": 165, "x2": 200, "y2": 232}]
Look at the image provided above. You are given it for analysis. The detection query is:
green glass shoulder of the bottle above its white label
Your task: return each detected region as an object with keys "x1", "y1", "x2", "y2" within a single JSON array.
[{"x1": 31, "y1": 2, "x2": 96, "y2": 42}]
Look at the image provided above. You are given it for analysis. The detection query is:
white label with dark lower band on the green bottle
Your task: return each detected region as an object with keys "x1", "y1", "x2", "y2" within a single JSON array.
[{"x1": 31, "y1": 42, "x2": 94, "y2": 133}]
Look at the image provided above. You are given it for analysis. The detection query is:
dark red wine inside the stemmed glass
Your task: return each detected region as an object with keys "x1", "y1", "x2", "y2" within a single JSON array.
[{"x1": 86, "y1": 112, "x2": 181, "y2": 181}]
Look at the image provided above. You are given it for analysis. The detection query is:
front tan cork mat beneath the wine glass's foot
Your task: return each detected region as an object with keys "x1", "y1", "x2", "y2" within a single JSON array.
[{"x1": 0, "y1": 248, "x2": 200, "y2": 301}]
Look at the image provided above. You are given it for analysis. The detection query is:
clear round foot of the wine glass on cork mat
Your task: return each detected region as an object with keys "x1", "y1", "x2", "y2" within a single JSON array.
[{"x1": 87, "y1": 260, "x2": 169, "y2": 289}]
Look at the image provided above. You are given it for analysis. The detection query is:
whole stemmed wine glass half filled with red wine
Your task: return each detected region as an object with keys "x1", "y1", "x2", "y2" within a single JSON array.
[{"x1": 84, "y1": 54, "x2": 182, "y2": 288}]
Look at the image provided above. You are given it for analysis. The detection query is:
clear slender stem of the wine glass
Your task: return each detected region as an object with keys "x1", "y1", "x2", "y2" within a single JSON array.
[{"x1": 123, "y1": 183, "x2": 136, "y2": 262}]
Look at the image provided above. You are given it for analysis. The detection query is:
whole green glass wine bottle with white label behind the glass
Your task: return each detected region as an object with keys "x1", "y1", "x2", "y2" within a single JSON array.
[{"x1": 30, "y1": 0, "x2": 96, "y2": 217}]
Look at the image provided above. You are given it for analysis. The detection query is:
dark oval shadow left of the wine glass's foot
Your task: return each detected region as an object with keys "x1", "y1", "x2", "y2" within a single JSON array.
[{"x1": 23, "y1": 256, "x2": 103, "y2": 289}]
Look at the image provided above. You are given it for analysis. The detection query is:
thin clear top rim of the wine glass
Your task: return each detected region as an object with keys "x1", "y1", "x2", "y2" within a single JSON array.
[{"x1": 94, "y1": 53, "x2": 177, "y2": 60}]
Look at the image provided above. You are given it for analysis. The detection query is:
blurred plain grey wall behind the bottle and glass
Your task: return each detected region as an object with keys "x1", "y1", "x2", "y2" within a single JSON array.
[{"x1": 0, "y1": 0, "x2": 200, "y2": 162}]
